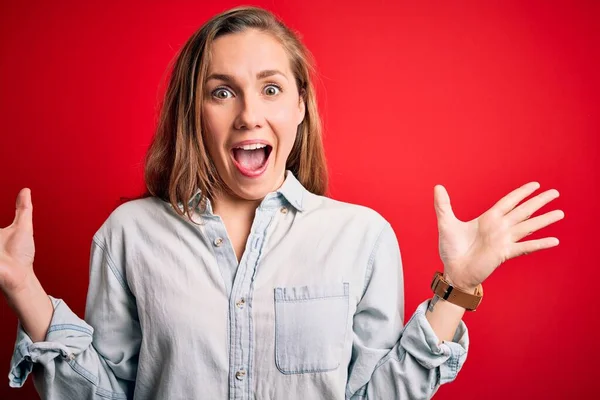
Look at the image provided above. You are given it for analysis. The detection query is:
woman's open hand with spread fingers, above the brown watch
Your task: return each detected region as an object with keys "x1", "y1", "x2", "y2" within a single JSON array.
[{"x1": 434, "y1": 182, "x2": 565, "y2": 291}]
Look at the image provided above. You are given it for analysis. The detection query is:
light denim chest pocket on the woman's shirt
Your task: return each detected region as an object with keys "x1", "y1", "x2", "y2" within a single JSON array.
[{"x1": 275, "y1": 282, "x2": 349, "y2": 374}]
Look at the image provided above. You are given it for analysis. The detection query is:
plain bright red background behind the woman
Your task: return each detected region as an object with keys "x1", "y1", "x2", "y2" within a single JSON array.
[{"x1": 0, "y1": 0, "x2": 600, "y2": 400}]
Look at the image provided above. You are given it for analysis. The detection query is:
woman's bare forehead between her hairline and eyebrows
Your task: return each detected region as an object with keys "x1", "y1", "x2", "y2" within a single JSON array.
[{"x1": 208, "y1": 29, "x2": 291, "y2": 77}]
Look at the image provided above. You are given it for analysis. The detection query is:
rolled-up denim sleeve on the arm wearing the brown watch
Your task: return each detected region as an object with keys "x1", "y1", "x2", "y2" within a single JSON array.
[{"x1": 346, "y1": 223, "x2": 469, "y2": 400}]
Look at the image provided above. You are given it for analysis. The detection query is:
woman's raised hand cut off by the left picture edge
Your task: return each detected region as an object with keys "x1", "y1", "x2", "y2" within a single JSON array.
[{"x1": 0, "y1": 188, "x2": 35, "y2": 297}]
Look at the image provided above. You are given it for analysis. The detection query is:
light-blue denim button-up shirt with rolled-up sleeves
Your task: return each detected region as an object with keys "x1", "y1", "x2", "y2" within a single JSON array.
[{"x1": 9, "y1": 171, "x2": 469, "y2": 400}]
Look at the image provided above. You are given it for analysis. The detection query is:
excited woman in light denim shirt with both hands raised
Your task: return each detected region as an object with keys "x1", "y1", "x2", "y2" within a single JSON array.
[{"x1": 0, "y1": 7, "x2": 564, "y2": 399}]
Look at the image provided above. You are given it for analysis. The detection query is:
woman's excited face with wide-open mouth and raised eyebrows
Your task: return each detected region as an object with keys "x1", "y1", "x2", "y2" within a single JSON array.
[{"x1": 203, "y1": 29, "x2": 305, "y2": 200}]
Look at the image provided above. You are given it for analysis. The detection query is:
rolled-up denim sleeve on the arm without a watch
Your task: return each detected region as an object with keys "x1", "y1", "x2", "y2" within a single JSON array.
[{"x1": 8, "y1": 236, "x2": 141, "y2": 400}]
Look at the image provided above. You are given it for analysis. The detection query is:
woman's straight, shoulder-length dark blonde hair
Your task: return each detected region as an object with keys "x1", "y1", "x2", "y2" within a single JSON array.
[{"x1": 142, "y1": 7, "x2": 328, "y2": 222}]
